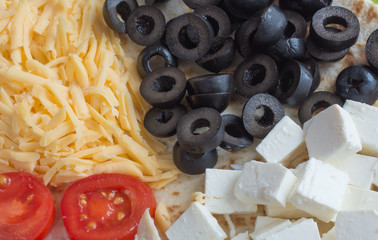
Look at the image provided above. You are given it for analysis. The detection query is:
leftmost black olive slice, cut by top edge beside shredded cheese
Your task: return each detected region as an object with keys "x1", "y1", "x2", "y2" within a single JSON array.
[{"x1": 102, "y1": 0, "x2": 138, "y2": 33}]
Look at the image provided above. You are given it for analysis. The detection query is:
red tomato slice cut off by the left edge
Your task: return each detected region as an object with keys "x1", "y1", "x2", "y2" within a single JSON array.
[{"x1": 0, "y1": 172, "x2": 55, "y2": 240}]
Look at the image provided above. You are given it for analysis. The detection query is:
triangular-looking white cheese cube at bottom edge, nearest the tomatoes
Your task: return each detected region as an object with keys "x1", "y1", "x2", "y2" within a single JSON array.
[{"x1": 165, "y1": 203, "x2": 227, "y2": 240}]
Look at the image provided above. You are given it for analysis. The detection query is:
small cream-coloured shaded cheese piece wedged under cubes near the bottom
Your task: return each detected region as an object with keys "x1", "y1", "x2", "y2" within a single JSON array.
[{"x1": 265, "y1": 202, "x2": 312, "y2": 218}]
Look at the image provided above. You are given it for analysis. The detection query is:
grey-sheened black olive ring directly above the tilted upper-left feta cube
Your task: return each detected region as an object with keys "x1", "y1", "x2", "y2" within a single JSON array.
[{"x1": 242, "y1": 93, "x2": 285, "y2": 139}]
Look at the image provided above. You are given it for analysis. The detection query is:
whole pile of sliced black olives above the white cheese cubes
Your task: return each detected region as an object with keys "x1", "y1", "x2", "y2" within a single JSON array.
[{"x1": 103, "y1": 0, "x2": 378, "y2": 174}]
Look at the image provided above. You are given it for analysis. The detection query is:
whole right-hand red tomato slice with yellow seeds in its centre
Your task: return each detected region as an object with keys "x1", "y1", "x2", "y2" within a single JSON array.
[{"x1": 61, "y1": 174, "x2": 156, "y2": 240}]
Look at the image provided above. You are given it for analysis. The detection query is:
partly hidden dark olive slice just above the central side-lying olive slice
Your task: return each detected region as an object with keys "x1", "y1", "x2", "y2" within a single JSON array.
[{"x1": 197, "y1": 38, "x2": 235, "y2": 73}]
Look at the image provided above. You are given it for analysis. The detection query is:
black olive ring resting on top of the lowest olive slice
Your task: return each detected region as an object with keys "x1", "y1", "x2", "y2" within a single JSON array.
[{"x1": 177, "y1": 108, "x2": 224, "y2": 154}]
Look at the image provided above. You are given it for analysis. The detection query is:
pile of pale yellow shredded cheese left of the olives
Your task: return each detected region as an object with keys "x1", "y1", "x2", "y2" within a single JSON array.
[{"x1": 0, "y1": 0, "x2": 179, "y2": 188}]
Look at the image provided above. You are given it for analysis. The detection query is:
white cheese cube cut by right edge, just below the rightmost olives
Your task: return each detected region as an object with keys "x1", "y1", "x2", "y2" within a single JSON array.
[{"x1": 343, "y1": 100, "x2": 378, "y2": 157}]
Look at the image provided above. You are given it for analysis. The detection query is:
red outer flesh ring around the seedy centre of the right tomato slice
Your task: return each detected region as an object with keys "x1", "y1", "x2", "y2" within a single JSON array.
[{"x1": 61, "y1": 174, "x2": 156, "y2": 240}]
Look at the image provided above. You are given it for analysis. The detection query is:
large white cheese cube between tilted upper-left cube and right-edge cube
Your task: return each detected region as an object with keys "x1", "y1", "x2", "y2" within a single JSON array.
[{"x1": 305, "y1": 104, "x2": 362, "y2": 160}]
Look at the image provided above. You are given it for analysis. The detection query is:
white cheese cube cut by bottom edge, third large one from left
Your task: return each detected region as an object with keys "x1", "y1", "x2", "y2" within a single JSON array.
[{"x1": 265, "y1": 218, "x2": 320, "y2": 240}]
